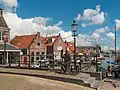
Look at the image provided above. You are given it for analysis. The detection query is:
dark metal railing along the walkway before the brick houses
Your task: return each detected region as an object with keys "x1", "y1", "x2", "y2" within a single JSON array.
[{"x1": 0, "y1": 55, "x2": 91, "y2": 71}]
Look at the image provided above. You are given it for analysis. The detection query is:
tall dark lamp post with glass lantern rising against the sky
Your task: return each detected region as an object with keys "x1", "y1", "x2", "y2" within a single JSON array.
[{"x1": 71, "y1": 20, "x2": 78, "y2": 70}]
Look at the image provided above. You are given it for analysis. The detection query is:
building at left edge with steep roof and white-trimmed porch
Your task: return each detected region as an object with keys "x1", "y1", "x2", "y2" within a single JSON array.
[{"x1": 0, "y1": 8, "x2": 21, "y2": 64}]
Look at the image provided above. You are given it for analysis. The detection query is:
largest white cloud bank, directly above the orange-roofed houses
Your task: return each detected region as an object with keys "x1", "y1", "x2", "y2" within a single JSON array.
[{"x1": 4, "y1": 12, "x2": 73, "y2": 41}]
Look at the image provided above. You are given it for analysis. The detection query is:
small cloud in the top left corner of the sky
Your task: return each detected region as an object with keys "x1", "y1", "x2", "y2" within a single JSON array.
[{"x1": 0, "y1": 0, "x2": 18, "y2": 12}]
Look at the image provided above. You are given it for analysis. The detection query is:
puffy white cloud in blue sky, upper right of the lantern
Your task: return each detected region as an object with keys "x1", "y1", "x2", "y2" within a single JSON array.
[{"x1": 76, "y1": 5, "x2": 105, "y2": 26}]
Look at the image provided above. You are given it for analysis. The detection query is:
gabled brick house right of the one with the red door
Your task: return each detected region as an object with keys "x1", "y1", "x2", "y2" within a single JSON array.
[{"x1": 45, "y1": 34, "x2": 66, "y2": 59}]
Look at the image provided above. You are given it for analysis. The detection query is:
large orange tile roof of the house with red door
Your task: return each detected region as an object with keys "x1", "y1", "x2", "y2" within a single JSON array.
[{"x1": 11, "y1": 34, "x2": 36, "y2": 49}]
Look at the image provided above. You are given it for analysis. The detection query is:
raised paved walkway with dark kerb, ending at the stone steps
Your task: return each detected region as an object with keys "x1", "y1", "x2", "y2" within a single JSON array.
[{"x1": 0, "y1": 68, "x2": 96, "y2": 90}]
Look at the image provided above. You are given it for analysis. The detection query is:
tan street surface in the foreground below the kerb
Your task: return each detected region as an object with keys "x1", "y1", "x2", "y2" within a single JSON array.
[{"x1": 0, "y1": 74, "x2": 92, "y2": 90}]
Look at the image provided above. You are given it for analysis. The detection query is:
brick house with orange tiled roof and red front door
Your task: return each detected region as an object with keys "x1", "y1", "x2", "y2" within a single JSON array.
[{"x1": 11, "y1": 32, "x2": 46, "y2": 65}]
